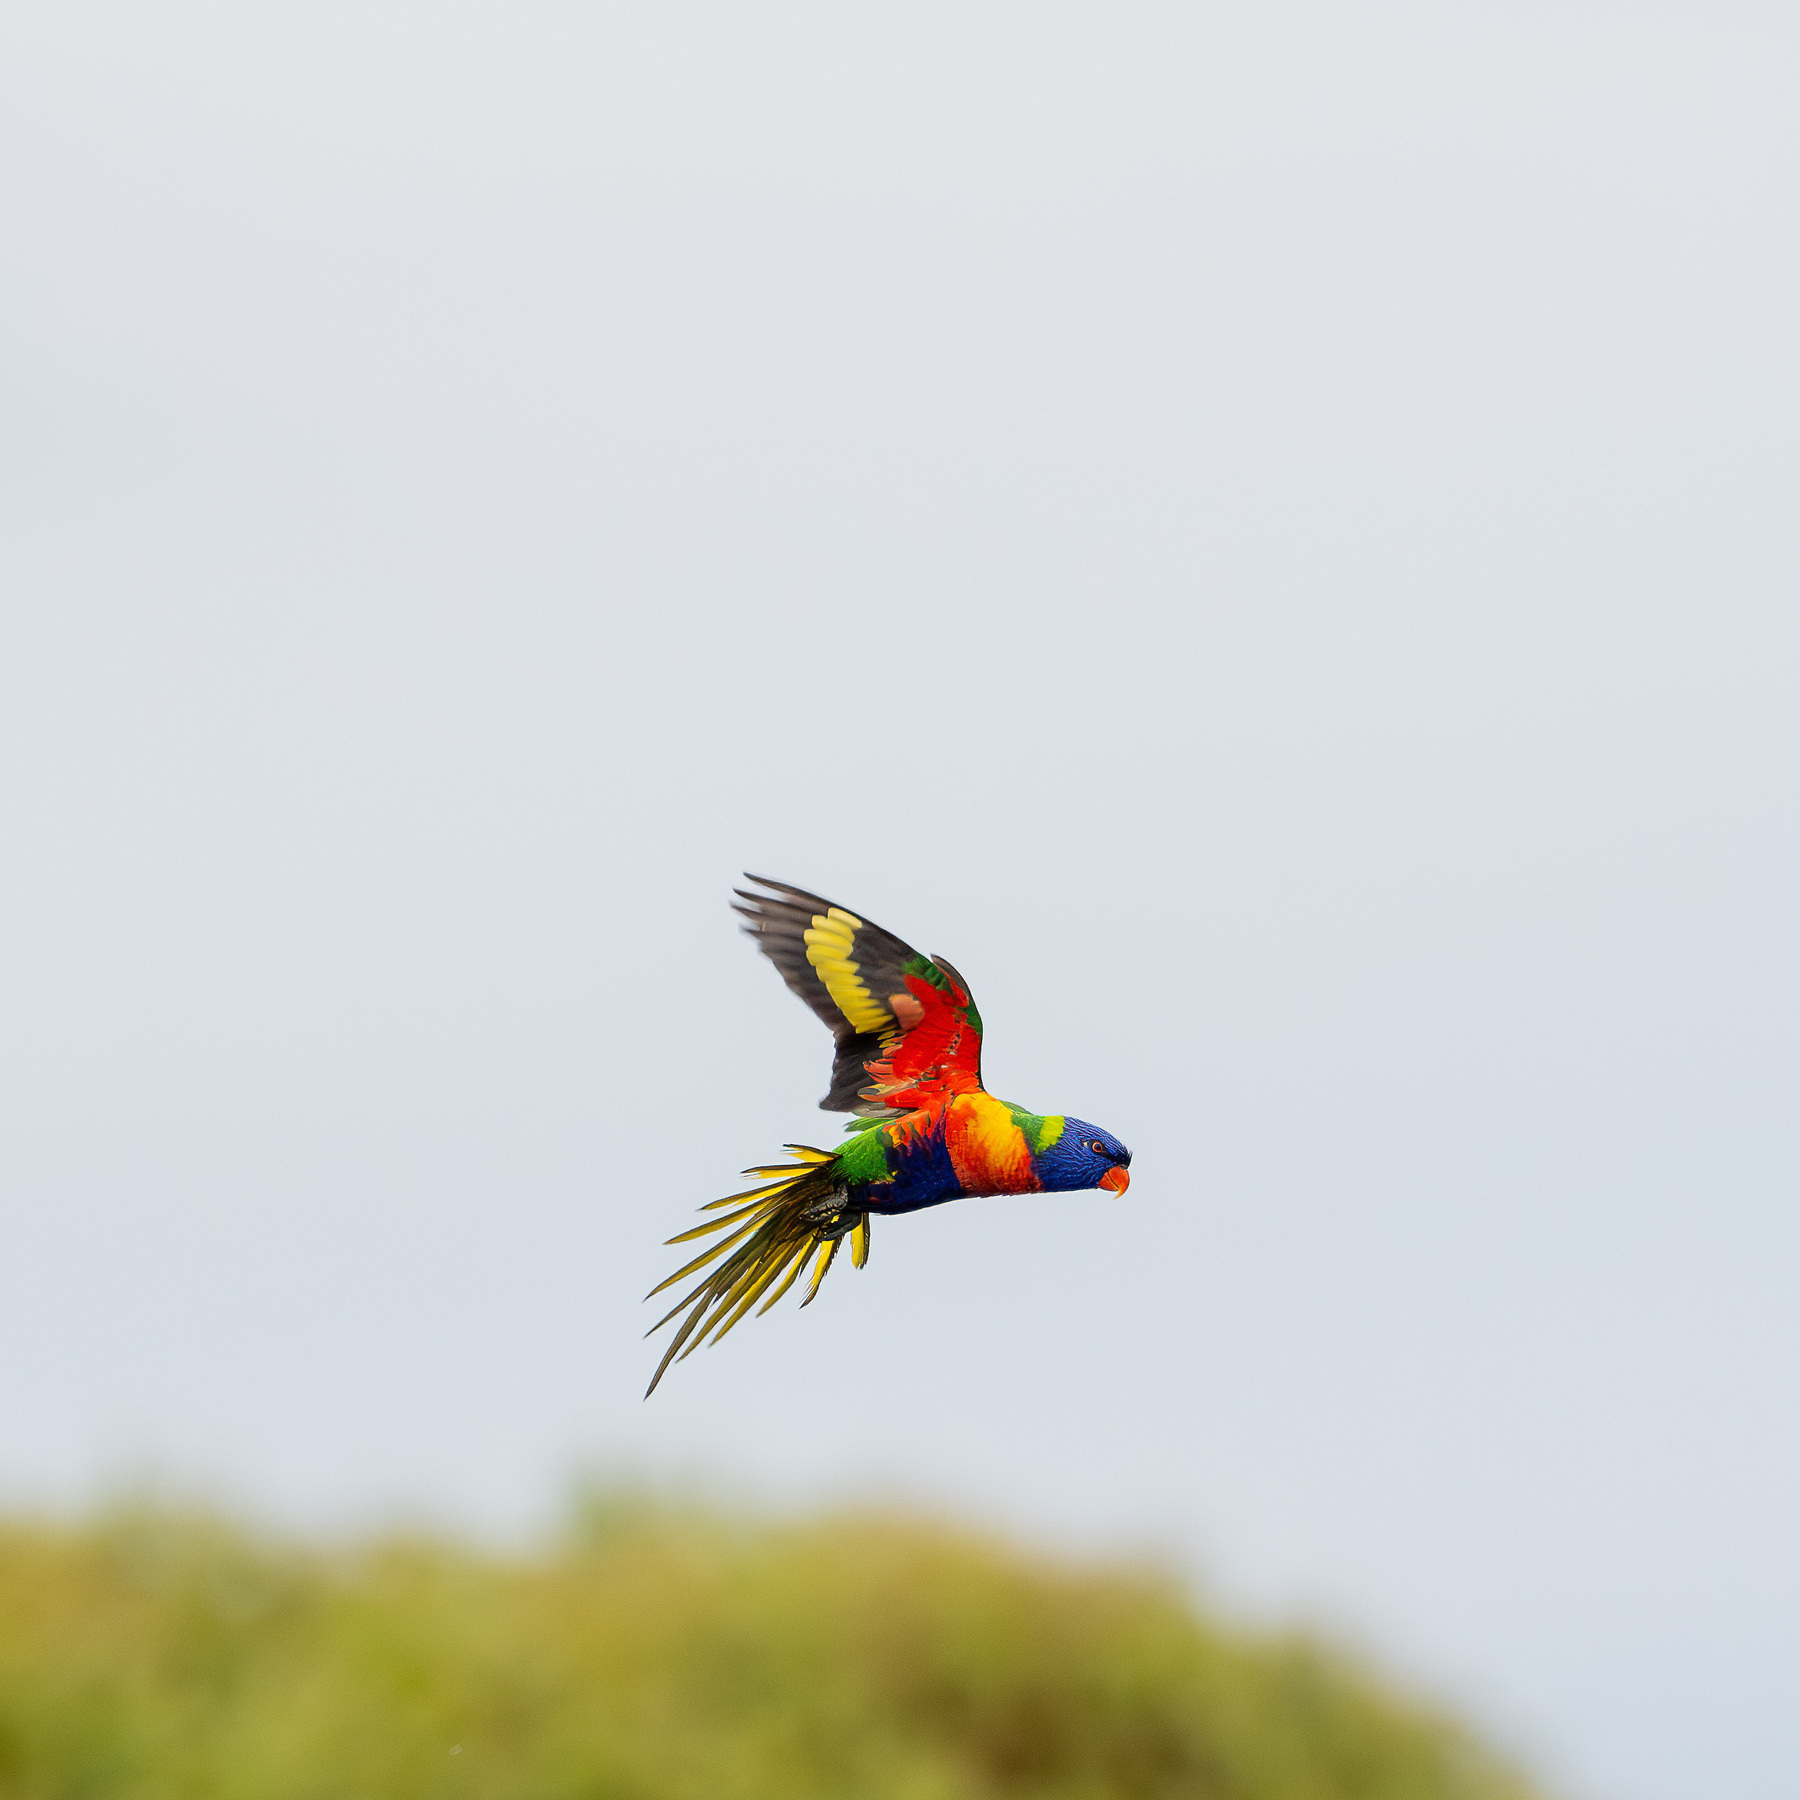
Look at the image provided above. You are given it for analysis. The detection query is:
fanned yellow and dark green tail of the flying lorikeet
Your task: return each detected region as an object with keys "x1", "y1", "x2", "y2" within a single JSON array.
[{"x1": 644, "y1": 1143, "x2": 869, "y2": 1400}]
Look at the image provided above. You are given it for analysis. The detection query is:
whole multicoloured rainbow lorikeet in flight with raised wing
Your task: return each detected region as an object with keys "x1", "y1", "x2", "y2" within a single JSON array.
[{"x1": 646, "y1": 875, "x2": 1130, "y2": 1399}]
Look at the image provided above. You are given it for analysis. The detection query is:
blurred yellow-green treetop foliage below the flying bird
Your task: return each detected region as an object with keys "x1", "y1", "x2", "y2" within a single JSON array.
[{"x1": 0, "y1": 1498, "x2": 1528, "y2": 1800}]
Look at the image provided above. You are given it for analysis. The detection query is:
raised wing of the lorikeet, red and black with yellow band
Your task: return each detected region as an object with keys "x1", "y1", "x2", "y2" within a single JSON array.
[{"x1": 734, "y1": 875, "x2": 981, "y2": 1118}]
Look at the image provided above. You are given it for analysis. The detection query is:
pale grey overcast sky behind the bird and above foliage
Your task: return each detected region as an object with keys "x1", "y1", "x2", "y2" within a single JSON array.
[{"x1": 0, "y1": 14, "x2": 1800, "y2": 1800}]
